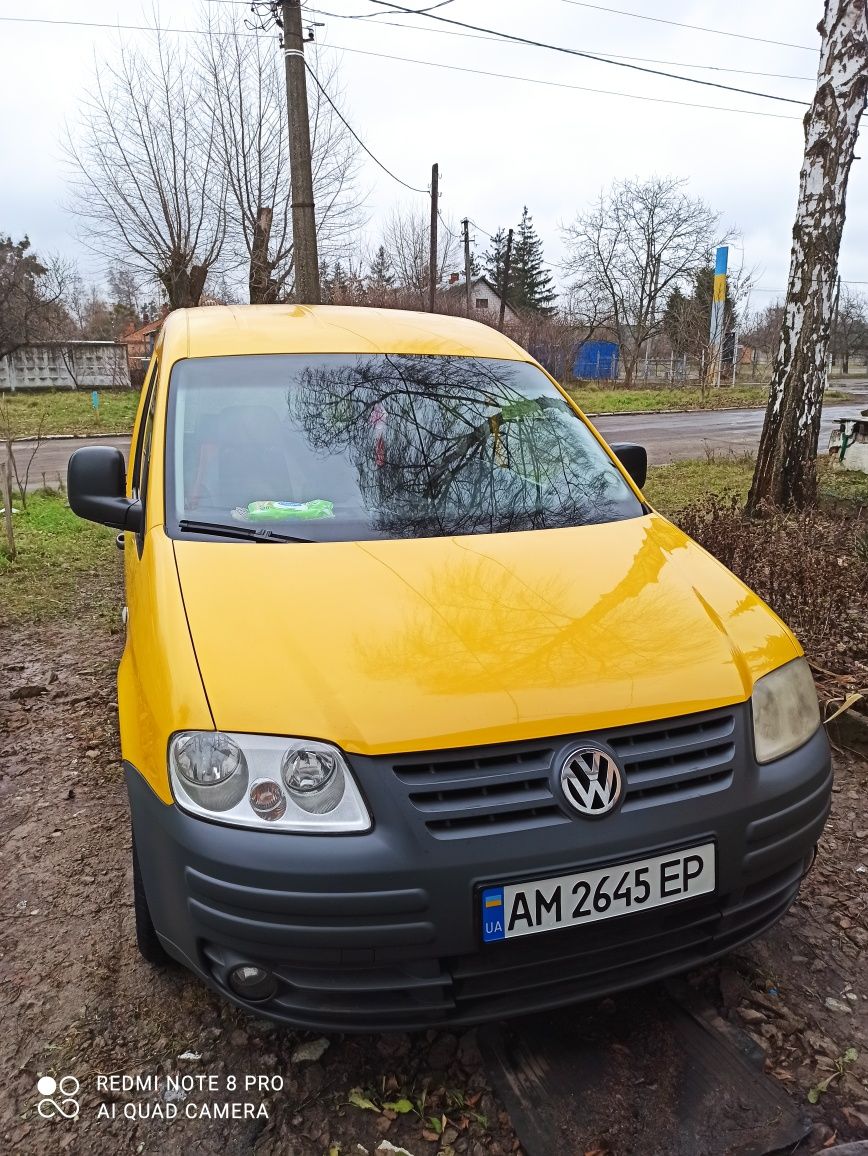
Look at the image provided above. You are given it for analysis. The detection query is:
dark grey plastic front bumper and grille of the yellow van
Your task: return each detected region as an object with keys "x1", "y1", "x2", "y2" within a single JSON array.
[{"x1": 126, "y1": 707, "x2": 832, "y2": 1031}]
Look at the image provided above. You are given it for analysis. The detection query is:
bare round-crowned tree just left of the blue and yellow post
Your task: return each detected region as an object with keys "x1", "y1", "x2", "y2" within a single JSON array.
[{"x1": 562, "y1": 177, "x2": 720, "y2": 385}]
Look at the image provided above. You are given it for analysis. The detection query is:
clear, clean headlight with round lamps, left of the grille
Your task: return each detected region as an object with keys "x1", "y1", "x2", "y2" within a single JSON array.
[{"x1": 169, "y1": 731, "x2": 371, "y2": 835}]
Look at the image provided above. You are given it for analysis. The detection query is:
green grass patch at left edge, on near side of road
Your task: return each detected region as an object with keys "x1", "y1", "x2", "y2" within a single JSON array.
[{"x1": 0, "y1": 490, "x2": 121, "y2": 624}]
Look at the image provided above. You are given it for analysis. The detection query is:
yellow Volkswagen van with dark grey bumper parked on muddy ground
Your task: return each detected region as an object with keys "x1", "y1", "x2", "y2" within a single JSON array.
[{"x1": 68, "y1": 305, "x2": 831, "y2": 1030}]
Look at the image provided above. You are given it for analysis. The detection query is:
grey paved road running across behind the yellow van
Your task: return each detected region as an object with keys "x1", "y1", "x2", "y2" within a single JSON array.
[{"x1": 15, "y1": 391, "x2": 868, "y2": 488}]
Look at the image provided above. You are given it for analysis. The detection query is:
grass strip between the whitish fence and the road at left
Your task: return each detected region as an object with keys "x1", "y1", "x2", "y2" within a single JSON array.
[{"x1": 0, "y1": 390, "x2": 139, "y2": 438}]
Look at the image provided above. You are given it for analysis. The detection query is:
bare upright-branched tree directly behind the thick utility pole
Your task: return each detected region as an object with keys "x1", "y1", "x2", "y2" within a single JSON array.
[{"x1": 198, "y1": 14, "x2": 363, "y2": 304}]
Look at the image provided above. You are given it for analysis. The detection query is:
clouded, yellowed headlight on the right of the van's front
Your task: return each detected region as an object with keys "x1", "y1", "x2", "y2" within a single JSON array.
[{"x1": 751, "y1": 658, "x2": 819, "y2": 763}]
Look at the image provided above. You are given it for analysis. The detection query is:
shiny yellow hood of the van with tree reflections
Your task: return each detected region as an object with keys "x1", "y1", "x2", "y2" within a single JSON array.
[{"x1": 175, "y1": 513, "x2": 801, "y2": 755}]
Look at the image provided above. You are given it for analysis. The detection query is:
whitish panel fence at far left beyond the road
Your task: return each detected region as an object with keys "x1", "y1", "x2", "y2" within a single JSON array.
[{"x1": 0, "y1": 341, "x2": 129, "y2": 392}]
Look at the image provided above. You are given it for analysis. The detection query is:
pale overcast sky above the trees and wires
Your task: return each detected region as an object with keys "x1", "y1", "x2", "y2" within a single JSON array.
[{"x1": 0, "y1": 0, "x2": 868, "y2": 307}]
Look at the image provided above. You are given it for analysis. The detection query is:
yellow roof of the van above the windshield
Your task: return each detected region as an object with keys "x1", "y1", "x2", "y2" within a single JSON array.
[{"x1": 163, "y1": 305, "x2": 532, "y2": 362}]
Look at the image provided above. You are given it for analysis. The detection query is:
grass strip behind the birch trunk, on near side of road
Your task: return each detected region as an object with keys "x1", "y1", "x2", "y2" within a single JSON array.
[{"x1": 644, "y1": 454, "x2": 868, "y2": 514}]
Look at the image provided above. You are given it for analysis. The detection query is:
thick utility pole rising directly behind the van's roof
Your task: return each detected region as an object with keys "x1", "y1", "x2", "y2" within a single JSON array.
[{"x1": 282, "y1": 0, "x2": 321, "y2": 305}]
